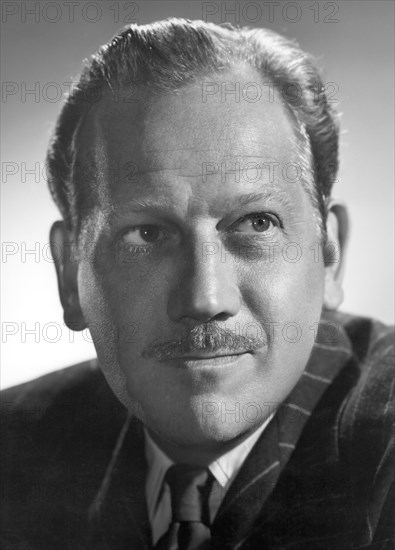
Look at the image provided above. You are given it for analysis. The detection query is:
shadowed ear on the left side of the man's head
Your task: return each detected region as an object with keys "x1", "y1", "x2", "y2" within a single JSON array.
[{"x1": 50, "y1": 221, "x2": 87, "y2": 331}]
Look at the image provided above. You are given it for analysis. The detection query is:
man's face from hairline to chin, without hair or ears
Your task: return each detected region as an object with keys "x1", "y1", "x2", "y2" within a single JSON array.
[{"x1": 73, "y1": 69, "x2": 324, "y2": 447}]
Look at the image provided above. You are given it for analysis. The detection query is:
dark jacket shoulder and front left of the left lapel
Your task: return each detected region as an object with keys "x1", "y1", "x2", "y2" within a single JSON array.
[{"x1": 1, "y1": 361, "x2": 127, "y2": 549}]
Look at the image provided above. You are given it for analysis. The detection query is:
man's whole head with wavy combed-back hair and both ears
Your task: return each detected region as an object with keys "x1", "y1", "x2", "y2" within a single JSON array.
[{"x1": 48, "y1": 19, "x2": 347, "y2": 462}]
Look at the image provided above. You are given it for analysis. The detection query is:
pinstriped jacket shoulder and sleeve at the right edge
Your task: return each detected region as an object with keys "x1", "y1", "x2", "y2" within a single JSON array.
[{"x1": 332, "y1": 315, "x2": 395, "y2": 545}]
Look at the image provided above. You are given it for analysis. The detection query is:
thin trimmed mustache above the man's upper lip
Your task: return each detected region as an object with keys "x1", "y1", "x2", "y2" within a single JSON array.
[{"x1": 142, "y1": 322, "x2": 267, "y2": 361}]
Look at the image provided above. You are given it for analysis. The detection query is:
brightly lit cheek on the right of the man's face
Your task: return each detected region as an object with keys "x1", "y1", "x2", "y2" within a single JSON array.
[{"x1": 242, "y1": 247, "x2": 324, "y2": 384}]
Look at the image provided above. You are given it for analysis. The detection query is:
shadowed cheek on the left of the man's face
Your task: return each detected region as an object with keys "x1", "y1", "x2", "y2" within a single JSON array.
[{"x1": 79, "y1": 263, "x2": 170, "y2": 417}]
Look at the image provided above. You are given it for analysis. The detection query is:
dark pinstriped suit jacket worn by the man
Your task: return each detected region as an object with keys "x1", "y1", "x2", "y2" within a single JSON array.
[{"x1": 1, "y1": 313, "x2": 395, "y2": 550}]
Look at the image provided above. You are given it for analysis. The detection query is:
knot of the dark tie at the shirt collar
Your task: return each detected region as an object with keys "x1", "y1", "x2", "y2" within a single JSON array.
[{"x1": 165, "y1": 464, "x2": 213, "y2": 525}]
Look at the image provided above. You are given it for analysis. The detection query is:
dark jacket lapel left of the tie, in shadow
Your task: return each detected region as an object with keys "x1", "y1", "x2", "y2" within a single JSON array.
[{"x1": 88, "y1": 416, "x2": 152, "y2": 550}]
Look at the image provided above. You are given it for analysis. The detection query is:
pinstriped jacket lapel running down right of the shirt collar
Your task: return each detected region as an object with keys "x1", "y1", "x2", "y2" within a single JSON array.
[{"x1": 212, "y1": 316, "x2": 352, "y2": 550}]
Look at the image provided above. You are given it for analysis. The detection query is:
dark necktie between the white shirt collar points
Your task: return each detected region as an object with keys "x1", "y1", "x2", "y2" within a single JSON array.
[{"x1": 155, "y1": 464, "x2": 214, "y2": 550}]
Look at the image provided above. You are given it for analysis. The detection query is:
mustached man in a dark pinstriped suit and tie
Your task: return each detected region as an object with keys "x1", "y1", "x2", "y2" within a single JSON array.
[{"x1": 3, "y1": 19, "x2": 395, "y2": 550}]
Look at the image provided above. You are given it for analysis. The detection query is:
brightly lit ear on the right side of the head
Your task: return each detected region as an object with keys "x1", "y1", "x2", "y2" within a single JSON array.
[{"x1": 323, "y1": 199, "x2": 349, "y2": 309}]
